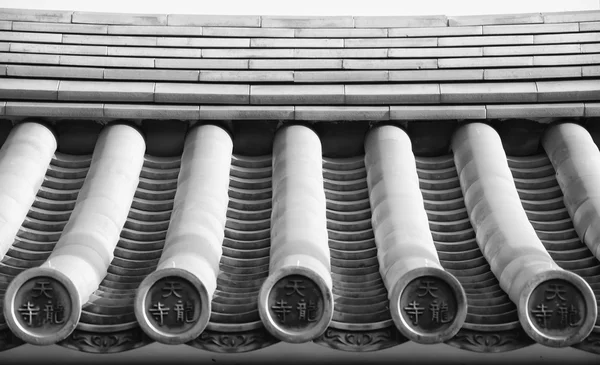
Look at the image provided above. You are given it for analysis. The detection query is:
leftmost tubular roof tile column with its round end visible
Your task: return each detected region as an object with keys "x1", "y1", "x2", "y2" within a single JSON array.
[{"x1": 4, "y1": 125, "x2": 146, "y2": 344}]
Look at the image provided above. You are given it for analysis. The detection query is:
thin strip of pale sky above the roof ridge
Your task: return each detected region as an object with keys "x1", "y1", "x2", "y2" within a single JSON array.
[{"x1": 0, "y1": 0, "x2": 600, "y2": 15}]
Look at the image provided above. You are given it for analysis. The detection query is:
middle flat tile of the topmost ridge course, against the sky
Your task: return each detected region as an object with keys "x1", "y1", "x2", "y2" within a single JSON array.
[{"x1": 261, "y1": 16, "x2": 354, "y2": 28}]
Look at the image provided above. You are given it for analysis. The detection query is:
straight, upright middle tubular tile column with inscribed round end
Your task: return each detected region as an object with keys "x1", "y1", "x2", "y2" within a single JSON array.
[{"x1": 259, "y1": 125, "x2": 333, "y2": 343}]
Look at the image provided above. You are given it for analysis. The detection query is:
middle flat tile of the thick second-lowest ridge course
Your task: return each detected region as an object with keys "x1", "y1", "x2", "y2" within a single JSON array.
[{"x1": 250, "y1": 85, "x2": 344, "y2": 105}]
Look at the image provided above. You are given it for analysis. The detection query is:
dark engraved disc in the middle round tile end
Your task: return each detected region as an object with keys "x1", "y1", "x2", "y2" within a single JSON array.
[{"x1": 268, "y1": 275, "x2": 324, "y2": 330}]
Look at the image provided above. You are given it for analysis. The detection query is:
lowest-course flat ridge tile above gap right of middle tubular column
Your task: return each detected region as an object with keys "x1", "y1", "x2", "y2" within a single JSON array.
[{"x1": 294, "y1": 106, "x2": 390, "y2": 121}]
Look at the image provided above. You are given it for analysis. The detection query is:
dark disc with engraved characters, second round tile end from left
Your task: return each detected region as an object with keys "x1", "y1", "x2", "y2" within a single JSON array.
[{"x1": 146, "y1": 277, "x2": 201, "y2": 334}]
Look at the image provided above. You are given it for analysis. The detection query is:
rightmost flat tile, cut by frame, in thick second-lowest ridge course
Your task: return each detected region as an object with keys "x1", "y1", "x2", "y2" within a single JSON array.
[{"x1": 536, "y1": 80, "x2": 600, "y2": 102}]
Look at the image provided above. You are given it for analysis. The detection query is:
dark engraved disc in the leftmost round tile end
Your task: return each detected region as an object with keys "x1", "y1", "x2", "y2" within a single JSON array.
[{"x1": 15, "y1": 277, "x2": 71, "y2": 335}]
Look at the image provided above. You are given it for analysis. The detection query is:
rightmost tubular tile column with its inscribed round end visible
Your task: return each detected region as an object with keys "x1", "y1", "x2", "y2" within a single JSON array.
[{"x1": 452, "y1": 123, "x2": 597, "y2": 347}]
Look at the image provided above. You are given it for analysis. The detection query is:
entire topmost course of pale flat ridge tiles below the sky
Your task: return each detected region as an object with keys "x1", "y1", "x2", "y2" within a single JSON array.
[{"x1": 0, "y1": 8, "x2": 600, "y2": 28}]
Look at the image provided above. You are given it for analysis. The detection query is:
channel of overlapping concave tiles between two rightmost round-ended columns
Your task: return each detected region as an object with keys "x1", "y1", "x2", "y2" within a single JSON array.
[{"x1": 416, "y1": 155, "x2": 533, "y2": 352}]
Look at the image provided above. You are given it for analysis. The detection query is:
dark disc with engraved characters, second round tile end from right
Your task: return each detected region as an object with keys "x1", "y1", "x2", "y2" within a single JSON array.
[{"x1": 399, "y1": 276, "x2": 457, "y2": 332}]
